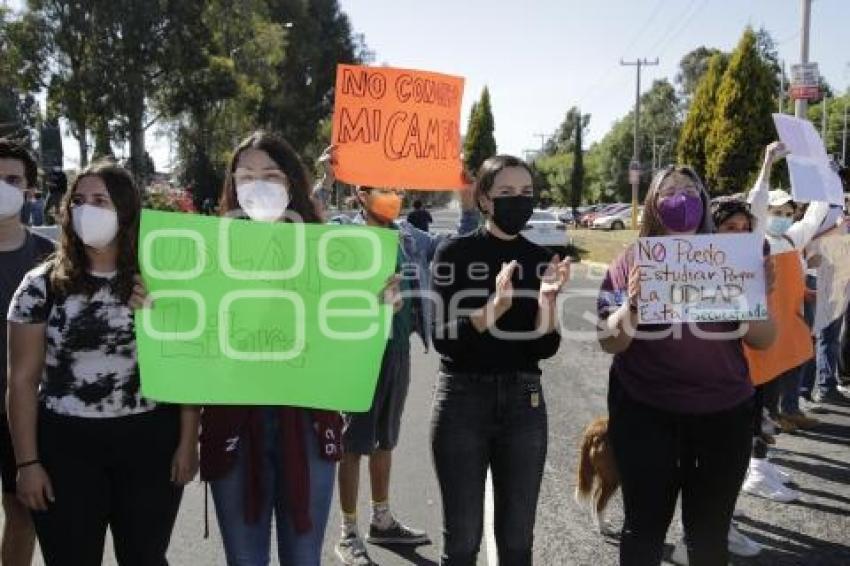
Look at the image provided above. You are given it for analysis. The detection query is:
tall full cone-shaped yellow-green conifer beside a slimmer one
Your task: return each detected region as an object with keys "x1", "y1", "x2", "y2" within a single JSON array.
[{"x1": 705, "y1": 28, "x2": 778, "y2": 193}]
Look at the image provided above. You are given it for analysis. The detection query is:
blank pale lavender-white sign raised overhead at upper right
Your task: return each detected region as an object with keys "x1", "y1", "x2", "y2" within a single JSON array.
[{"x1": 773, "y1": 114, "x2": 844, "y2": 204}]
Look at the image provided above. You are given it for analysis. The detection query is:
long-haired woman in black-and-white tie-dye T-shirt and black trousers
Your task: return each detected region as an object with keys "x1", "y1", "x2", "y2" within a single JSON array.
[{"x1": 8, "y1": 163, "x2": 198, "y2": 566}]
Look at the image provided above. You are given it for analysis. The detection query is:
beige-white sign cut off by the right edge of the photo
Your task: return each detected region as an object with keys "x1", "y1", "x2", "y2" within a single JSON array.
[{"x1": 813, "y1": 235, "x2": 850, "y2": 333}]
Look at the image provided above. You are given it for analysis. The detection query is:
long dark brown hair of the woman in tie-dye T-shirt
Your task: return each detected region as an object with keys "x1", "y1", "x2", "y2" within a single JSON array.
[{"x1": 50, "y1": 161, "x2": 142, "y2": 301}]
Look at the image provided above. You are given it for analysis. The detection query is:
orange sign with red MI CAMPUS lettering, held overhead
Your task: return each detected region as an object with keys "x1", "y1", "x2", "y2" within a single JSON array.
[{"x1": 332, "y1": 65, "x2": 466, "y2": 190}]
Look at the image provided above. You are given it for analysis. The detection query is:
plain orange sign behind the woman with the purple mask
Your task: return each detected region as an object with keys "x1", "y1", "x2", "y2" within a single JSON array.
[{"x1": 744, "y1": 251, "x2": 814, "y2": 385}]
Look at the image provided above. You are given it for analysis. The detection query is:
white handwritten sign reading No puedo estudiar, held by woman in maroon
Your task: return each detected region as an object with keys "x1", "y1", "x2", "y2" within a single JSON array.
[{"x1": 635, "y1": 234, "x2": 767, "y2": 324}]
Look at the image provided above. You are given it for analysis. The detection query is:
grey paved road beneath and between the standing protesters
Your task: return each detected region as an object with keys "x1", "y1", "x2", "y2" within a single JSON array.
[{"x1": 8, "y1": 216, "x2": 850, "y2": 566}]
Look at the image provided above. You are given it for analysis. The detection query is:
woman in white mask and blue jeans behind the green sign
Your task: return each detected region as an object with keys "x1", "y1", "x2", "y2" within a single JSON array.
[{"x1": 201, "y1": 132, "x2": 358, "y2": 566}]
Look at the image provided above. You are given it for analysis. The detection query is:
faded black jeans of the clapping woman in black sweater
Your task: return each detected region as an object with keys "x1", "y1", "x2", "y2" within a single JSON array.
[{"x1": 431, "y1": 373, "x2": 547, "y2": 566}]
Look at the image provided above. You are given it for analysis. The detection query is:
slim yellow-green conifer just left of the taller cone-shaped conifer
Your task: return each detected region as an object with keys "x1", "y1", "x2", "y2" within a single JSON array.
[{"x1": 676, "y1": 53, "x2": 728, "y2": 179}]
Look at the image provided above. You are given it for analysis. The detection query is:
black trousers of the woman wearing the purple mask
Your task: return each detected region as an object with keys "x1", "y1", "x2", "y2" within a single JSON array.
[{"x1": 608, "y1": 377, "x2": 753, "y2": 566}]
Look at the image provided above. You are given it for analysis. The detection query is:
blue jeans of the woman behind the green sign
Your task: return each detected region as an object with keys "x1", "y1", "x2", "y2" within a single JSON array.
[{"x1": 210, "y1": 411, "x2": 336, "y2": 566}]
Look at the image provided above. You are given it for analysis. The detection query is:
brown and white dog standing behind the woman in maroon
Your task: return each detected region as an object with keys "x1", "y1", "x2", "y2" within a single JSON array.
[{"x1": 575, "y1": 417, "x2": 620, "y2": 535}]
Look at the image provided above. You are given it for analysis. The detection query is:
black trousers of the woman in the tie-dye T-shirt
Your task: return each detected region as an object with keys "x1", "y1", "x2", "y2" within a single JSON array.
[{"x1": 33, "y1": 407, "x2": 183, "y2": 566}]
